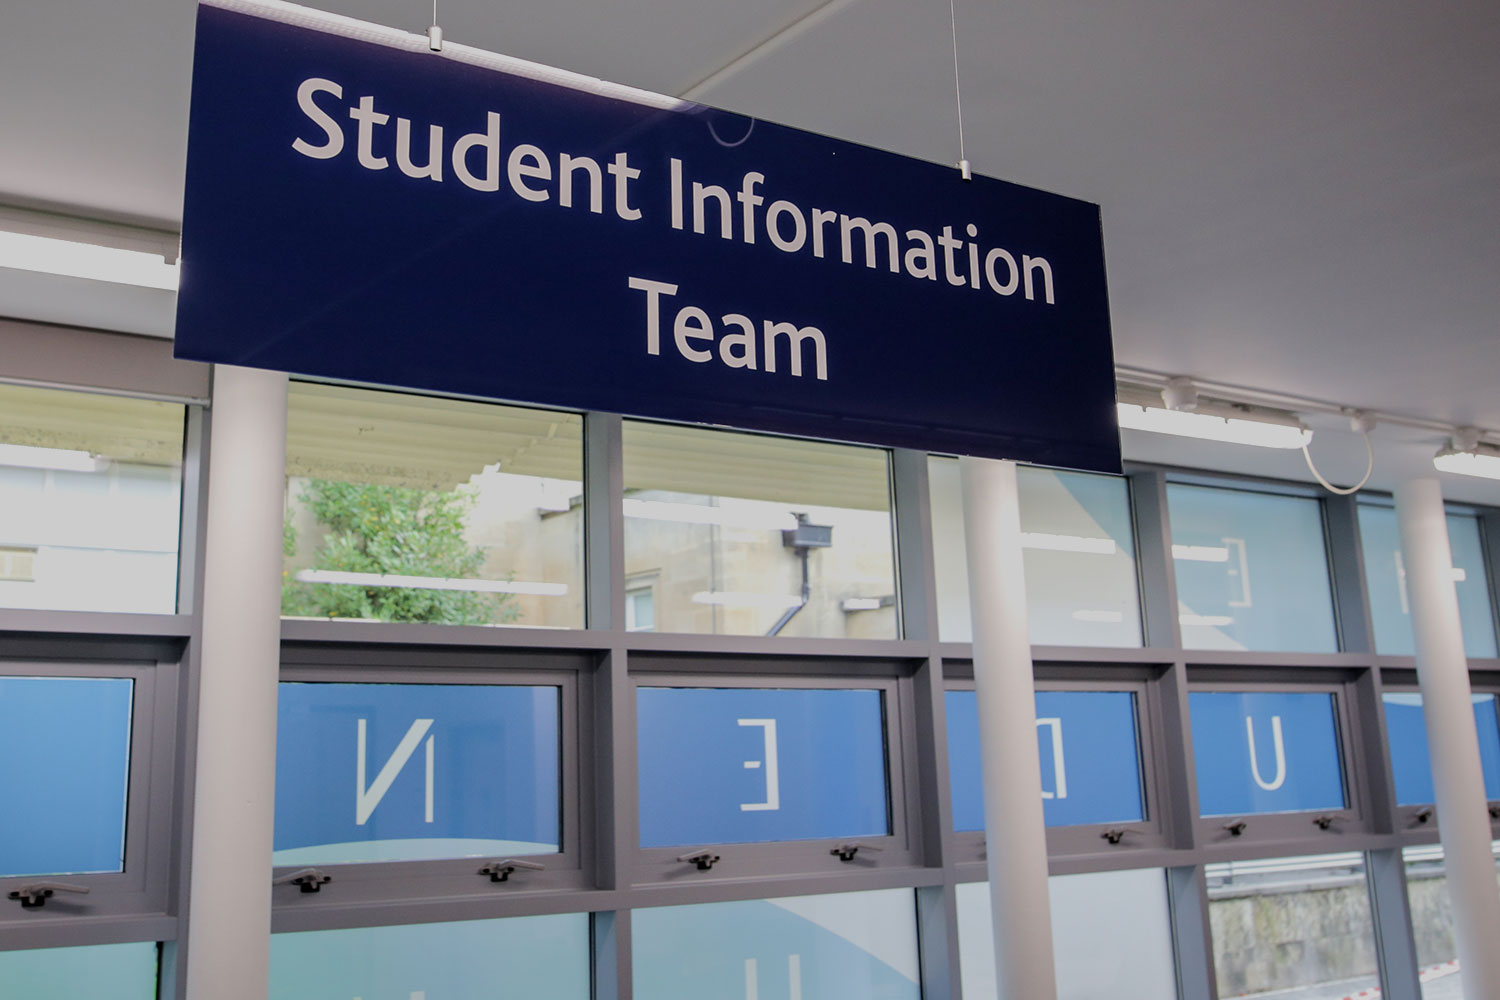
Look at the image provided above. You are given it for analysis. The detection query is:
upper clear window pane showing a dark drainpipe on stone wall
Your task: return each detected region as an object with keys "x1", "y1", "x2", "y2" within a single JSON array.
[{"x1": 624, "y1": 421, "x2": 897, "y2": 639}]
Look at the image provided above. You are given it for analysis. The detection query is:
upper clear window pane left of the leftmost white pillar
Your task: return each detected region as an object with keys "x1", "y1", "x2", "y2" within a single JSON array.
[{"x1": 0, "y1": 385, "x2": 185, "y2": 615}]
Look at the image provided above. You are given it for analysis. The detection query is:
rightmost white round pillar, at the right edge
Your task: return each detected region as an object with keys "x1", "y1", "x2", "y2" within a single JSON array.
[{"x1": 1397, "y1": 478, "x2": 1500, "y2": 1000}]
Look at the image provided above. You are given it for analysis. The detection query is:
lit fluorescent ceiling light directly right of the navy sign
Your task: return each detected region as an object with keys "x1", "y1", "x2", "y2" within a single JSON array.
[{"x1": 1116, "y1": 376, "x2": 1313, "y2": 450}]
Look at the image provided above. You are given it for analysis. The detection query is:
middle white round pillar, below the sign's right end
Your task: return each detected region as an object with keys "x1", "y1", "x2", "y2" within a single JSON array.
[{"x1": 960, "y1": 459, "x2": 1058, "y2": 1000}]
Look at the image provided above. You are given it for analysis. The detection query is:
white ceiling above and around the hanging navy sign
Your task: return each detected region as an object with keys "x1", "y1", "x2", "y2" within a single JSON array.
[{"x1": 0, "y1": 0, "x2": 1500, "y2": 504}]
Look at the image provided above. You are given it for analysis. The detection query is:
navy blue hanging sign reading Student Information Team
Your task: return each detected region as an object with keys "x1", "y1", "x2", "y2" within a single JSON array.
[{"x1": 177, "y1": 0, "x2": 1121, "y2": 472}]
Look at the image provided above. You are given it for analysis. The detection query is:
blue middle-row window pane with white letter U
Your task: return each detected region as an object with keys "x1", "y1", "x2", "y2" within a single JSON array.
[{"x1": 1188, "y1": 691, "x2": 1346, "y2": 816}]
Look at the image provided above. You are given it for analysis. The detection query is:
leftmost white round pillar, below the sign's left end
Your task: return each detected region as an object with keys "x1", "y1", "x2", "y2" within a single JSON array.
[{"x1": 188, "y1": 364, "x2": 287, "y2": 1000}]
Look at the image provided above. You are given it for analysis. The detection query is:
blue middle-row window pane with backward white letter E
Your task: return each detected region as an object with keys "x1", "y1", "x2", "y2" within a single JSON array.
[{"x1": 636, "y1": 688, "x2": 891, "y2": 847}]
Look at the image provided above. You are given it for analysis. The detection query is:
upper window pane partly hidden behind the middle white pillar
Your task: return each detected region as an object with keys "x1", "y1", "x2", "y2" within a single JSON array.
[{"x1": 927, "y1": 457, "x2": 1142, "y2": 646}]
